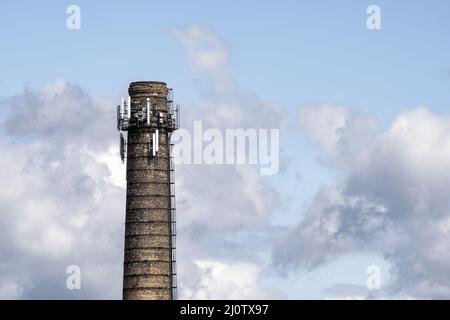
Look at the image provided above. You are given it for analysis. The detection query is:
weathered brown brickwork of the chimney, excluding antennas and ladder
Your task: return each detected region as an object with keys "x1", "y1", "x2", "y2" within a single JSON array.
[{"x1": 123, "y1": 82, "x2": 172, "y2": 300}]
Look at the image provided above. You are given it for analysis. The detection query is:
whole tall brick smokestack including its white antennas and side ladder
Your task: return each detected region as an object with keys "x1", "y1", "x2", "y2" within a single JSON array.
[{"x1": 117, "y1": 81, "x2": 179, "y2": 300}]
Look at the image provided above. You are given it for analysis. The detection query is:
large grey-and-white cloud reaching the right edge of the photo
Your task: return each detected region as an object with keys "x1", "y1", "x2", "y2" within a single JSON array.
[{"x1": 275, "y1": 107, "x2": 450, "y2": 298}]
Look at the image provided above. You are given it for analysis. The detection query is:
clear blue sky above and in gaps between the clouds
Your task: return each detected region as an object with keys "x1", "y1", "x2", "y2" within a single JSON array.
[{"x1": 0, "y1": 0, "x2": 450, "y2": 297}]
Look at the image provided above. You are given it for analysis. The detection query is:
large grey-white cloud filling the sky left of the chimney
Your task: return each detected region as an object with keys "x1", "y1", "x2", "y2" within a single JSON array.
[{"x1": 0, "y1": 79, "x2": 125, "y2": 299}]
